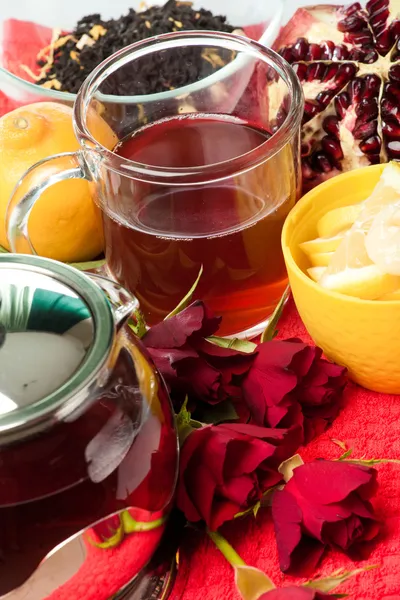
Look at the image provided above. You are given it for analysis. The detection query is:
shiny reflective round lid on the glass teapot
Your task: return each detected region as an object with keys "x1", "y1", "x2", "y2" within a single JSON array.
[{"x1": 0, "y1": 254, "x2": 115, "y2": 442}]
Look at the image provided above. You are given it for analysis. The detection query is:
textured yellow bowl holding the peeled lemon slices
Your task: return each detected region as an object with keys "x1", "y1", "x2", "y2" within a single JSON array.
[{"x1": 282, "y1": 165, "x2": 400, "y2": 394}]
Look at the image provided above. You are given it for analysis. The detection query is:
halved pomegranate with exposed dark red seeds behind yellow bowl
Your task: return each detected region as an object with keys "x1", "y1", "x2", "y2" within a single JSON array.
[{"x1": 274, "y1": 0, "x2": 400, "y2": 191}]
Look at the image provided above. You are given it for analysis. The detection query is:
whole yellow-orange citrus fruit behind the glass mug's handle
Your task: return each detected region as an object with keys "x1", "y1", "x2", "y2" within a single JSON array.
[{"x1": 0, "y1": 102, "x2": 117, "y2": 262}]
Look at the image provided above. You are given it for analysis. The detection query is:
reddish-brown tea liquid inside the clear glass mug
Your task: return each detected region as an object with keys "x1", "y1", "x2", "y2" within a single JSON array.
[{"x1": 103, "y1": 113, "x2": 295, "y2": 333}]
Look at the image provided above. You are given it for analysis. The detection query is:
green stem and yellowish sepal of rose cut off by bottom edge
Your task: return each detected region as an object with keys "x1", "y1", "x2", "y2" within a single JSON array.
[{"x1": 207, "y1": 530, "x2": 275, "y2": 600}]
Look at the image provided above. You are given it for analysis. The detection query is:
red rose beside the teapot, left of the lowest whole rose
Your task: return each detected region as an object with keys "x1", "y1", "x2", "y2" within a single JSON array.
[{"x1": 177, "y1": 423, "x2": 301, "y2": 530}]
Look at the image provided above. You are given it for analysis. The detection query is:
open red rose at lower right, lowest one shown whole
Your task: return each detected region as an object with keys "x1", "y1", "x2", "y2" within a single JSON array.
[{"x1": 272, "y1": 460, "x2": 378, "y2": 574}]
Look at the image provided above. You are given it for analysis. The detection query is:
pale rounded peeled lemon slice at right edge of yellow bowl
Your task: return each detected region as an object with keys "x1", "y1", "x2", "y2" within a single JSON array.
[{"x1": 365, "y1": 202, "x2": 400, "y2": 275}]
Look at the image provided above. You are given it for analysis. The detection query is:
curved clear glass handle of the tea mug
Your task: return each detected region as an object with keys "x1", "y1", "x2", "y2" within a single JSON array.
[{"x1": 6, "y1": 151, "x2": 92, "y2": 254}]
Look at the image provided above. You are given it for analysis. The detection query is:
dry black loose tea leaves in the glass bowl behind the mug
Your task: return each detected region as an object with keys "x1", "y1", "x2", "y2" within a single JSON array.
[{"x1": 25, "y1": 0, "x2": 241, "y2": 95}]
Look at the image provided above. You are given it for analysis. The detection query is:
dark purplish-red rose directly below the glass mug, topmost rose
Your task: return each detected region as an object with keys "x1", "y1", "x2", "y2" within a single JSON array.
[{"x1": 143, "y1": 301, "x2": 255, "y2": 406}]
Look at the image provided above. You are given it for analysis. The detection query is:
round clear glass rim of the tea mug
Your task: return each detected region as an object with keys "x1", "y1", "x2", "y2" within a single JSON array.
[{"x1": 74, "y1": 30, "x2": 304, "y2": 185}]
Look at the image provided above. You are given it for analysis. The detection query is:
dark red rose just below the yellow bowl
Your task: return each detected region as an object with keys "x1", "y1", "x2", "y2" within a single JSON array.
[{"x1": 242, "y1": 339, "x2": 346, "y2": 442}]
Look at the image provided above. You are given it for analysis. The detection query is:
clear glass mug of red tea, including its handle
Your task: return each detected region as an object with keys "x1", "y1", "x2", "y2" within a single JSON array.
[{"x1": 8, "y1": 32, "x2": 303, "y2": 335}]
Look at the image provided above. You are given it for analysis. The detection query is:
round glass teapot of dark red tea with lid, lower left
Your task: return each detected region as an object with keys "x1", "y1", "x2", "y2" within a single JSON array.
[{"x1": 0, "y1": 254, "x2": 178, "y2": 600}]
